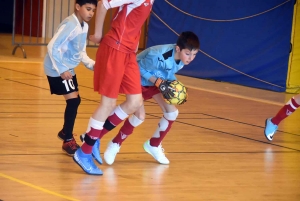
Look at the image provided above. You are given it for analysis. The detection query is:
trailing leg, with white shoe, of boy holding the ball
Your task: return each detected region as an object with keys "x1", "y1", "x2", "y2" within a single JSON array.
[{"x1": 104, "y1": 100, "x2": 145, "y2": 165}]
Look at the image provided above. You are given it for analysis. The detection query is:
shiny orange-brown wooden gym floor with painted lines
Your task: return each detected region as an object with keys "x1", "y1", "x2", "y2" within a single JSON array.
[{"x1": 0, "y1": 35, "x2": 300, "y2": 201}]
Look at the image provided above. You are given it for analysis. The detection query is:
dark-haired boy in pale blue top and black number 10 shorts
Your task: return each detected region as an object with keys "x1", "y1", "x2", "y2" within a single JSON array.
[{"x1": 44, "y1": 0, "x2": 97, "y2": 156}]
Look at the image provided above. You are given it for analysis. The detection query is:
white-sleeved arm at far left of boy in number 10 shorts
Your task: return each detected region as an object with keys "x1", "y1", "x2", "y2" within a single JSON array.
[{"x1": 47, "y1": 23, "x2": 75, "y2": 79}]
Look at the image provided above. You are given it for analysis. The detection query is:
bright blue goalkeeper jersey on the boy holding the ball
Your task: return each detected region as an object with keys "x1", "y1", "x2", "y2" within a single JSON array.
[{"x1": 137, "y1": 44, "x2": 184, "y2": 86}]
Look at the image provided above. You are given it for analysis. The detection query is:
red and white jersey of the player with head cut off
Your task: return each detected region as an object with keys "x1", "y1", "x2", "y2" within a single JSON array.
[{"x1": 101, "y1": 0, "x2": 154, "y2": 52}]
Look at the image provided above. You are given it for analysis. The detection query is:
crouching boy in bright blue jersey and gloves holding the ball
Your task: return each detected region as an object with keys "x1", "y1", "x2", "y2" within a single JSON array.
[{"x1": 81, "y1": 31, "x2": 200, "y2": 165}]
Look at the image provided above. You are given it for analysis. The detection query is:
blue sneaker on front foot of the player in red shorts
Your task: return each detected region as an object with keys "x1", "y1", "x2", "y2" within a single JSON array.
[{"x1": 73, "y1": 148, "x2": 103, "y2": 175}]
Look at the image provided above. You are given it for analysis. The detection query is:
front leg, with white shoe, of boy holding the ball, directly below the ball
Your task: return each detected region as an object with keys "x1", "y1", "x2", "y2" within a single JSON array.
[{"x1": 144, "y1": 94, "x2": 178, "y2": 164}]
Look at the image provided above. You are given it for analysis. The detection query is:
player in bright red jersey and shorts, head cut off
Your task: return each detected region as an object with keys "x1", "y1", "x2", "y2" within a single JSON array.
[{"x1": 73, "y1": 0, "x2": 154, "y2": 175}]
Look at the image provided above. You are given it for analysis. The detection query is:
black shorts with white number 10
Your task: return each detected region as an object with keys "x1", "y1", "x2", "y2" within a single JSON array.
[{"x1": 47, "y1": 75, "x2": 78, "y2": 95}]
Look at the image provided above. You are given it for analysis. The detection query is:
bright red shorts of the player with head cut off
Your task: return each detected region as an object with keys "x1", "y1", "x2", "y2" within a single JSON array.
[{"x1": 94, "y1": 43, "x2": 141, "y2": 98}]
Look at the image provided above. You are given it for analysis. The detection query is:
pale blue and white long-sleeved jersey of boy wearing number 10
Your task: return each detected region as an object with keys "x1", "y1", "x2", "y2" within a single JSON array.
[{"x1": 44, "y1": 14, "x2": 95, "y2": 77}]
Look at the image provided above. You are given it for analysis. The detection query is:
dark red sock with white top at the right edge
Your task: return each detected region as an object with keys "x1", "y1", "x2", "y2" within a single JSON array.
[{"x1": 271, "y1": 97, "x2": 299, "y2": 125}]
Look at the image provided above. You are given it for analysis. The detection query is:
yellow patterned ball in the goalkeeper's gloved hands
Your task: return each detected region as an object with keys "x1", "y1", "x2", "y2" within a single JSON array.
[{"x1": 165, "y1": 80, "x2": 187, "y2": 105}]
